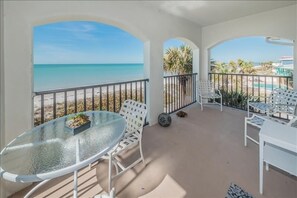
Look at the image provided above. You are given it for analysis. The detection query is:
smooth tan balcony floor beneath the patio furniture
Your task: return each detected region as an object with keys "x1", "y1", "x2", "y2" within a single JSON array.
[{"x1": 13, "y1": 104, "x2": 297, "y2": 198}]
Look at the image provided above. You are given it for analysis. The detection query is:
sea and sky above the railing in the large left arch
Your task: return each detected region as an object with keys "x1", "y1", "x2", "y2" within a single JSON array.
[{"x1": 33, "y1": 21, "x2": 144, "y2": 92}]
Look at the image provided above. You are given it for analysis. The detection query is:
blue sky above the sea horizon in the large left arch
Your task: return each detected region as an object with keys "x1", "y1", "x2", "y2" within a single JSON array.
[{"x1": 34, "y1": 22, "x2": 143, "y2": 64}]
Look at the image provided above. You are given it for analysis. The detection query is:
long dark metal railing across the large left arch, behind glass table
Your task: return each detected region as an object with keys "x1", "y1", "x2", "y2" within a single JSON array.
[{"x1": 34, "y1": 79, "x2": 149, "y2": 126}]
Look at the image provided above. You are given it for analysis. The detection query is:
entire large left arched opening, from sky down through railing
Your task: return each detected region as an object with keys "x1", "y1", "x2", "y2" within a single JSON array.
[{"x1": 33, "y1": 21, "x2": 146, "y2": 125}]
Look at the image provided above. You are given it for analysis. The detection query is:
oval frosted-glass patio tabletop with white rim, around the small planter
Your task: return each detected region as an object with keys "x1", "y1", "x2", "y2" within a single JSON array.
[{"x1": 0, "y1": 111, "x2": 126, "y2": 182}]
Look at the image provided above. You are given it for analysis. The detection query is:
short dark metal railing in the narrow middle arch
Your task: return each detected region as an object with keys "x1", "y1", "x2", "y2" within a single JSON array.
[{"x1": 164, "y1": 73, "x2": 197, "y2": 113}]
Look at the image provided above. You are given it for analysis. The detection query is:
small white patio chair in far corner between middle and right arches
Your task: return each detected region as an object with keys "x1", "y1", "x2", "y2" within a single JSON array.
[{"x1": 197, "y1": 81, "x2": 223, "y2": 111}]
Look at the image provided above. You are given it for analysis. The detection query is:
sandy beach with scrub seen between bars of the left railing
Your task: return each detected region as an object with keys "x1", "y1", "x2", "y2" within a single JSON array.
[{"x1": 34, "y1": 83, "x2": 144, "y2": 126}]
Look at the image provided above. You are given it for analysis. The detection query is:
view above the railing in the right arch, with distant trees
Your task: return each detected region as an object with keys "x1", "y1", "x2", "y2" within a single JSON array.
[{"x1": 210, "y1": 37, "x2": 294, "y2": 76}]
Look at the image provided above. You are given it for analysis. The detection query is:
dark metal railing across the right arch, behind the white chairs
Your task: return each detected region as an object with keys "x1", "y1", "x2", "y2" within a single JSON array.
[{"x1": 209, "y1": 73, "x2": 293, "y2": 110}]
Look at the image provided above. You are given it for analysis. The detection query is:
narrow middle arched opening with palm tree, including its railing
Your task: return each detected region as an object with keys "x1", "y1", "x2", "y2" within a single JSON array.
[{"x1": 163, "y1": 38, "x2": 199, "y2": 113}]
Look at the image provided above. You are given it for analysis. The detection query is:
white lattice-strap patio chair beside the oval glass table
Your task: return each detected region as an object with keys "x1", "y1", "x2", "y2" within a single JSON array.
[{"x1": 108, "y1": 100, "x2": 147, "y2": 191}]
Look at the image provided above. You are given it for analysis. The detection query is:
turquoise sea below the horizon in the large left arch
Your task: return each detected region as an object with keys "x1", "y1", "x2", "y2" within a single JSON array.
[{"x1": 34, "y1": 64, "x2": 144, "y2": 92}]
